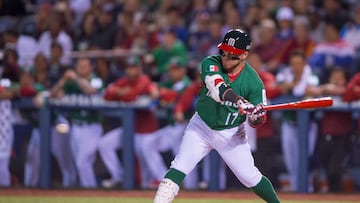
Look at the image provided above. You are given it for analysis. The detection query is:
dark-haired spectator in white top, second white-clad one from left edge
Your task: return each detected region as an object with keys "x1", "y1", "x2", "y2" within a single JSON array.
[{"x1": 39, "y1": 14, "x2": 73, "y2": 65}]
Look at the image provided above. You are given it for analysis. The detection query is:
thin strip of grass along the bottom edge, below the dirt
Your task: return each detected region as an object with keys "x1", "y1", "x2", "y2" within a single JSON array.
[{"x1": 0, "y1": 196, "x2": 354, "y2": 203}]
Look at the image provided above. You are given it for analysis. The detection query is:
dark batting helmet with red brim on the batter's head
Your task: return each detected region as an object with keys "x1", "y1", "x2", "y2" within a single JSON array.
[{"x1": 217, "y1": 29, "x2": 251, "y2": 55}]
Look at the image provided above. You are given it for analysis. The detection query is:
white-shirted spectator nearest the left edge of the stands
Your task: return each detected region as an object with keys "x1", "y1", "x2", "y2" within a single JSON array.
[{"x1": 4, "y1": 29, "x2": 38, "y2": 68}]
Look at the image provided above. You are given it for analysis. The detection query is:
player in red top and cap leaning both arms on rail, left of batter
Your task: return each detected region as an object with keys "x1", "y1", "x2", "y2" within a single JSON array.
[{"x1": 99, "y1": 57, "x2": 159, "y2": 188}]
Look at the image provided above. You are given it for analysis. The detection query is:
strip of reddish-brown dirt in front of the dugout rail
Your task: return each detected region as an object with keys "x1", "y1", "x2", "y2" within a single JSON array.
[{"x1": 0, "y1": 188, "x2": 360, "y2": 202}]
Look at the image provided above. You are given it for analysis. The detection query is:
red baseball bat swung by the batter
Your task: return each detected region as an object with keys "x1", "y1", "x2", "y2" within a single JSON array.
[{"x1": 264, "y1": 97, "x2": 333, "y2": 111}]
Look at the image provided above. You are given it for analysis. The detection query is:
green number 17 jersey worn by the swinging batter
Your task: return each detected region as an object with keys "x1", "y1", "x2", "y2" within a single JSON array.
[{"x1": 196, "y1": 56, "x2": 266, "y2": 130}]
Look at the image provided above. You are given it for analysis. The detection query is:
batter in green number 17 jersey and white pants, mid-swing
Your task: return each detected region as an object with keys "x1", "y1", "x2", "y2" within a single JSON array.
[{"x1": 154, "y1": 29, "x2": 280, "y2": 203}]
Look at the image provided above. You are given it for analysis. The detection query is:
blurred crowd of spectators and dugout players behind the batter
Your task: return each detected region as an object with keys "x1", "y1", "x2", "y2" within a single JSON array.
[{"x1": 0, "y1": 0, "x2": 360, "y2": 192}]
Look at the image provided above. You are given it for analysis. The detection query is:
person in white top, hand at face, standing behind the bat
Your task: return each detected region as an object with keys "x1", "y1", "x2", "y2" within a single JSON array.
[{"x1": 276, "y1": 50, "x2": 319, "y2": 191}]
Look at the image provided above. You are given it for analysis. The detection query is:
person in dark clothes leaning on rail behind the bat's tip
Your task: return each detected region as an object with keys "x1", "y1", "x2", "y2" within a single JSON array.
[{"x1": 309, "y1": 67, "x2": 353, "y2": 192}]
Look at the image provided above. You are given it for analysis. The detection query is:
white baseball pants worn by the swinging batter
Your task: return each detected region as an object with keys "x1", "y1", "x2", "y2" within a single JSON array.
[{"x1": 171, "y1": 113, "x2": 262, "y2": 188}]
